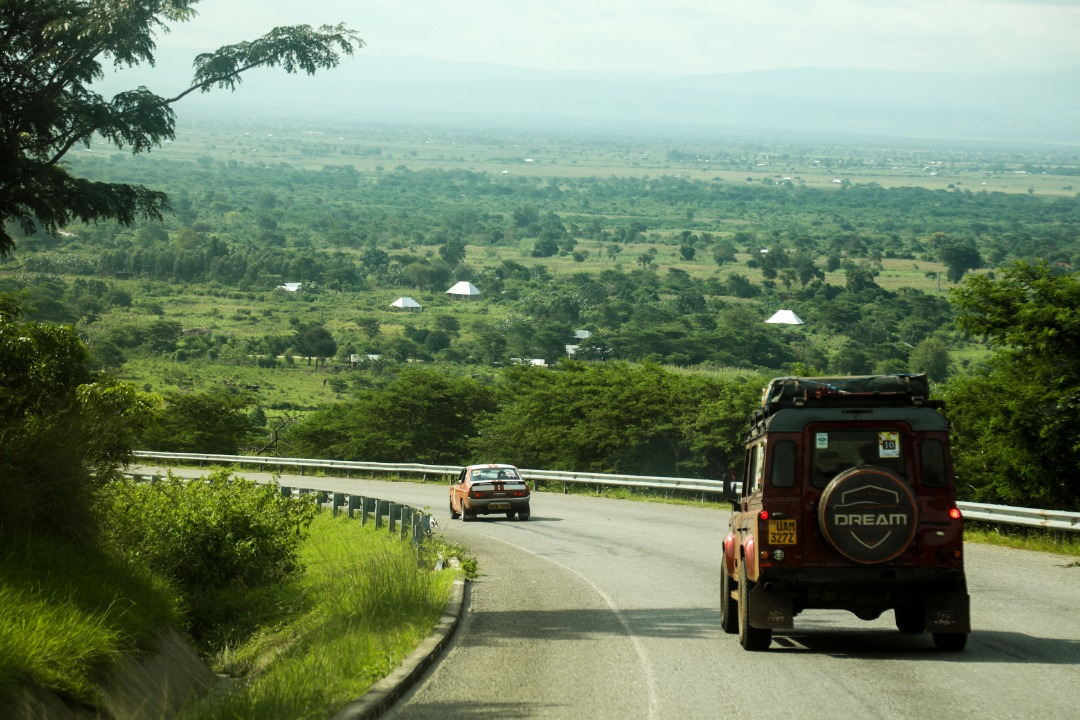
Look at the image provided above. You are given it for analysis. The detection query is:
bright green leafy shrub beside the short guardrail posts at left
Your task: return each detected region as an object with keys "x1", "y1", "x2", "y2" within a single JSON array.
[{"x1": 100, "y1": 471, "x2": 316, "y2": 640}]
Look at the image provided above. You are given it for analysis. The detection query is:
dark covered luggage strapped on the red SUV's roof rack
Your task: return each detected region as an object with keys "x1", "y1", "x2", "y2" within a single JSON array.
[{"x1": 761, "y1": 373, "x2": 937, "y2": 413}]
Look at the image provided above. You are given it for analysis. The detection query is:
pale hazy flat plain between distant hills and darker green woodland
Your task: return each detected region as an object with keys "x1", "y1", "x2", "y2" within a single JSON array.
[{"x1": 130, "y1": 121, "x2": 1080, "y2": 195}]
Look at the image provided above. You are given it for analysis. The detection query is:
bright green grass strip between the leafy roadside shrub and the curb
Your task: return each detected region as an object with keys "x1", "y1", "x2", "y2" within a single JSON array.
[{"x1": 186, "y1": 513, "x2": 457, "y2": 719}]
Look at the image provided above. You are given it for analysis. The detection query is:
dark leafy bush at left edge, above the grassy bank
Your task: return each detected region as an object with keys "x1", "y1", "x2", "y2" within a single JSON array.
[{"x1": 0, "y1": 296, "x2": 149, "y2": 539}]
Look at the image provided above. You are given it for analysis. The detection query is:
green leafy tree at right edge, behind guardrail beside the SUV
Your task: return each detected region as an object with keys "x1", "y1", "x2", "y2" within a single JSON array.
[{"x1": 945, "y1": 262, "x2": 1080, "y2": 510}]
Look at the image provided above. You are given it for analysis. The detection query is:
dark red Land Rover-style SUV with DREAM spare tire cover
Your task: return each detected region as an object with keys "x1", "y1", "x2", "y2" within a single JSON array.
[{"x1": 720, "y1": 375, "x2": 971, "y2": 651}]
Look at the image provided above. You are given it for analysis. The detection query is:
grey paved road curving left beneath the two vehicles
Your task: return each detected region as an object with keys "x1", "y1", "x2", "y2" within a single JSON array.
[{"x1": 132, "y1": 474, "x2": 1080, "y2": 720}]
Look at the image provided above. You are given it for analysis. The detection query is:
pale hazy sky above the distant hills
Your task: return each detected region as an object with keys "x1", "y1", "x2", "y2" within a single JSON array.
[{"x1": 159, "y1": 0, "x2": 1080, "y2": 74}]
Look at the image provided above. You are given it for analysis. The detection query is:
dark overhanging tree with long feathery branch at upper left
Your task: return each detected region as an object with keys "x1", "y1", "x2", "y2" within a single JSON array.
[{"x1": 0, "y1": 0, "x2": 364, "y2": 256}]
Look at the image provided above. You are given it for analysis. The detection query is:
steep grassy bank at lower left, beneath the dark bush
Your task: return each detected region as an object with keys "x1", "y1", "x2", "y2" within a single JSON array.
[{"x1": 0, "y1": 536, "x2": 176, "y2": 707}]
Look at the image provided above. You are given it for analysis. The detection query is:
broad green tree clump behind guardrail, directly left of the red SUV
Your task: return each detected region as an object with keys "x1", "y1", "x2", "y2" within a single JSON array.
[{"x1": 472, "y1": 362, "x2": 764, "y2": 477}]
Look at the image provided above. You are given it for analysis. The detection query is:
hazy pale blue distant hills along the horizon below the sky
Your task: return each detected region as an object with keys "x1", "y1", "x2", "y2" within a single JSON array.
[{"x1": 97, "y1": 51, "x2": 1080, "y2": 145}]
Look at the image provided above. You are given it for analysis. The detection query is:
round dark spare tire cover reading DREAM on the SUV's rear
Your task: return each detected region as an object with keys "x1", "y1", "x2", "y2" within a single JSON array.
[{"x1": 818, "y1": 465, "x2": 919, "y2": 565}]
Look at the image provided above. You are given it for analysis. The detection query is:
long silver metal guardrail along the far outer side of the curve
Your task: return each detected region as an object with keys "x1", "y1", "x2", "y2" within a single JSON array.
[{"x1": 128, "y1": 450, "x2": 1080, "y2": 532}]
